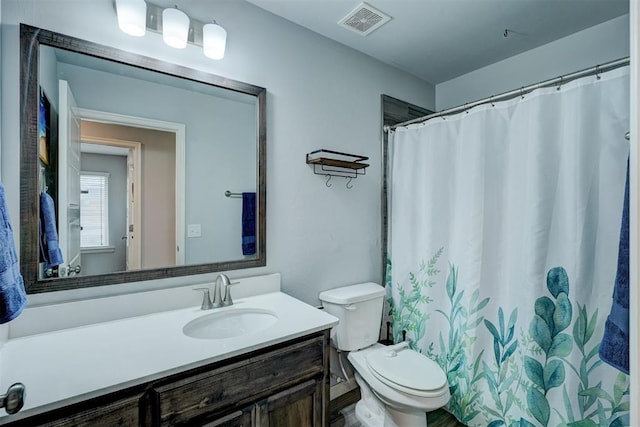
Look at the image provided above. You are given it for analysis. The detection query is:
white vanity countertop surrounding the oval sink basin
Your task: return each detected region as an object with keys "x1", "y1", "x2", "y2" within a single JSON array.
[{"x1": 0, "y1": 292, "x2": 338, "y2": 422}]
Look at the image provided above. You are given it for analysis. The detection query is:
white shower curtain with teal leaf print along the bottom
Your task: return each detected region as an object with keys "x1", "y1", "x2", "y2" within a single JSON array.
[{"x1": 385, "y1": 67, "x2": 629, "y2": 427}]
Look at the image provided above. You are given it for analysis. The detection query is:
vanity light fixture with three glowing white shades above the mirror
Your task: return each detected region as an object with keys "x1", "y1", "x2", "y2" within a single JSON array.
[{"x1": 115, "y1": 0, "x2": 227, "y2": 59}]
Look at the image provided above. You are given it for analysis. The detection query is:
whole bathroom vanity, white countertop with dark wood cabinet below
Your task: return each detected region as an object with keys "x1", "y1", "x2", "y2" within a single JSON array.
[{"x1": 0, "y1": 284, "x2": 337, "y2": 426}]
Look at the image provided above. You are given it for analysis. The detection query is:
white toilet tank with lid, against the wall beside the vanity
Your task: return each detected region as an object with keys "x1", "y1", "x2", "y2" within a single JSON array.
[{"x1": 318, "y1": 283, "x2": 385, "y2": 351}]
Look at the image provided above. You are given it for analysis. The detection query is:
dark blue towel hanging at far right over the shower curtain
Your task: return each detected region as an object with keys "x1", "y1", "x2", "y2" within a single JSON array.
[{"x1": 600, "y1": 163, "x2": 629, "y2": 375}]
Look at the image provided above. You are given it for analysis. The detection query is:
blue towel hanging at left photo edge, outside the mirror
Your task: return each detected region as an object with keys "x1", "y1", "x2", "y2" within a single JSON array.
[{"x1": 0, "y1": 183, "x2": 27, "y2": 323}]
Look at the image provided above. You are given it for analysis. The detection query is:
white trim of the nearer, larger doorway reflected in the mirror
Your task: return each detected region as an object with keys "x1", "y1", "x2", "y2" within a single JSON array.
[{"x1": 77, "y1": 108, "x2": 186, "y2": 265}]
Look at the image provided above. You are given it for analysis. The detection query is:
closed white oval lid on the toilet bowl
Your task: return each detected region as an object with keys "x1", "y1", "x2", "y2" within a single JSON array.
[{"x1": 367, "y1": 348, "x2": 447, "y2": 396}]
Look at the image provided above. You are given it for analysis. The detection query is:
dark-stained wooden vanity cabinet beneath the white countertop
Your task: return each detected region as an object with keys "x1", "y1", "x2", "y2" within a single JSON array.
[{"x1": 0, "y1": 330, "x2": 329, "y2": 427}]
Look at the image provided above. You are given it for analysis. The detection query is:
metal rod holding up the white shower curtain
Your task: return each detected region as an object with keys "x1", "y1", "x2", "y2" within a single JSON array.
[{"x1": 384, "y1": 56, "x2": 629, "y2": 132}]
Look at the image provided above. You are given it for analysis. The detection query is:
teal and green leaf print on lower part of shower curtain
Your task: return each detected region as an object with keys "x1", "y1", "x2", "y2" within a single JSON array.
[{"x1": 389, "y1": 260, "x2": 629, "y2": 427}]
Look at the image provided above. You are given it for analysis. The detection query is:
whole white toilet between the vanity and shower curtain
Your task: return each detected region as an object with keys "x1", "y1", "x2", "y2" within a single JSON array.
[{"x1": 319, "y1": 283, "x2": 451, "y2": 427}]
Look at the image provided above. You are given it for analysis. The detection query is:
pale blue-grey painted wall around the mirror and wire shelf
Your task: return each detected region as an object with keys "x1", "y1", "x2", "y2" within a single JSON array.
[{"x1": 2, "y1": 0, "x2": 435, "y2": 304}]
